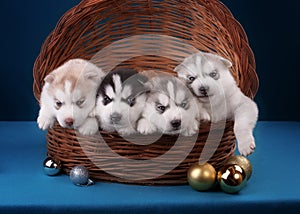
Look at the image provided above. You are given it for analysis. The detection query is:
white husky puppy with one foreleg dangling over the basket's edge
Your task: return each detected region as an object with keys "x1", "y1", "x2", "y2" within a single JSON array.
[{"x1": 175, "y1": 52, "x2": 258, "y2": 156}]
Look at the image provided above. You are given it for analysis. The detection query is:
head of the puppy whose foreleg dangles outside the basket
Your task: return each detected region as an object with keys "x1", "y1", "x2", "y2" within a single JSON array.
[{"x1": 175, "y1": 52, "x2": 234, "y2": 100}]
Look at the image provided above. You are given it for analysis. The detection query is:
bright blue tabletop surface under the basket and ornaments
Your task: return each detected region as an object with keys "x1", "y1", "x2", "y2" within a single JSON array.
[{"x1": 0, "y1": 122, "x2": 300, "y2": 213}]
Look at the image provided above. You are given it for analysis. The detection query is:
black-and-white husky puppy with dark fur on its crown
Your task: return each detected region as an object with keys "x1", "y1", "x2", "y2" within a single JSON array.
[{"x1": 95, "y1": 68, "x2": 148, "y2": 135}]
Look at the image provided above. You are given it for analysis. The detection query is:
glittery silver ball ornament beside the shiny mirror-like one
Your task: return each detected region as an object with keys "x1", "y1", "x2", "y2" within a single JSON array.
[{"x1": 70, "y1": 166, "x2": 94, "y2": 186}]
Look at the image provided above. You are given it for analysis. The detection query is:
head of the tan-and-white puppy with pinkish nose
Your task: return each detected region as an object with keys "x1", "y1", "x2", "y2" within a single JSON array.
[{"x1": 45, "y1": 59, "x2": 104, "y2": 128}]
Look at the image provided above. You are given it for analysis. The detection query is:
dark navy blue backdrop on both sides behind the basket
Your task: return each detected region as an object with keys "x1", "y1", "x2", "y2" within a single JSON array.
[{"x1": 0, "y1": 0, "x2": 300, "y2": 121}]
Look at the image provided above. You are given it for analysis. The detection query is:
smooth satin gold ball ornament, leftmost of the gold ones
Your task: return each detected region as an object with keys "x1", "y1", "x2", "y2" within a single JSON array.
[{"x1": 187, "y1": 163, "x2": 217, "y2": 191}]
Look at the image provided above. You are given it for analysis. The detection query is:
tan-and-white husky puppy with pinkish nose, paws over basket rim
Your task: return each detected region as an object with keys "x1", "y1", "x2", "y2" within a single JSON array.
[{"x1": 37, "y1": 59, "x2": 104, "y2": 135}]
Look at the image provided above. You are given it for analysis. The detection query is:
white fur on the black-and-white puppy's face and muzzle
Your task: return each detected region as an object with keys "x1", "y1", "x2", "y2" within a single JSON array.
[{"x1": 95, "y1": 71, "x2": 146, "y2": 136}]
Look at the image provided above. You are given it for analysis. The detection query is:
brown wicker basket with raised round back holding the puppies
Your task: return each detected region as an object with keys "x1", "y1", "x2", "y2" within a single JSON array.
[{"x1": 33, "y1": 0, "x2": 258, "y2": 185}]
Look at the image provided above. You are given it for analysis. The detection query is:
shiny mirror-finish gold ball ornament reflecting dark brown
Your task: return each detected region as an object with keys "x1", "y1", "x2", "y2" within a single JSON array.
[{"x1": 217, "y1": 164, "x2": 247, "y2": 193}]
